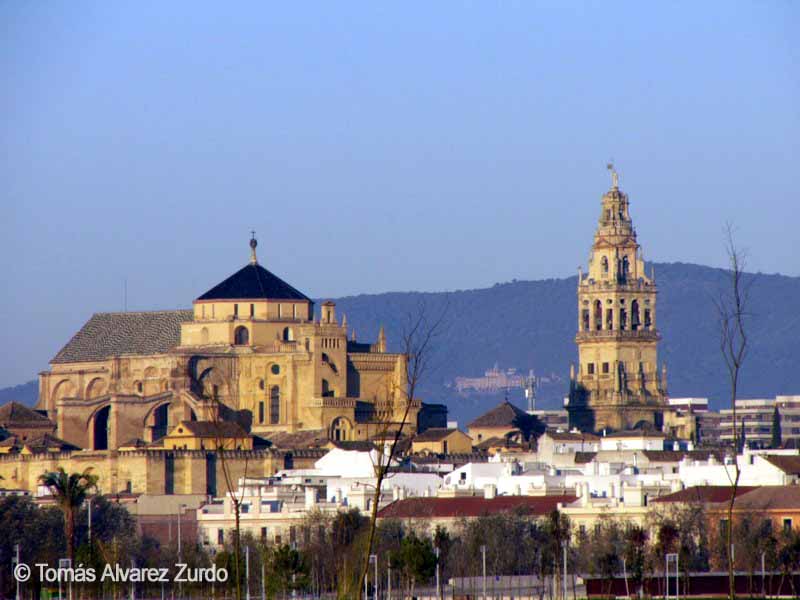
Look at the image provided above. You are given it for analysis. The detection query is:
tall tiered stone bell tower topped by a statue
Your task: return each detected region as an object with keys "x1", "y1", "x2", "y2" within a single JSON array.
[{"x1": 567, "y1": 164, "x2": 667, "y2": 431}]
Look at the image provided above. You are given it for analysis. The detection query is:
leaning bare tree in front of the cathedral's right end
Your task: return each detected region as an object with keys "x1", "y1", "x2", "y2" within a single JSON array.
[{"x1": 355, "y1": 303, "x2": 448, "y2": 599}]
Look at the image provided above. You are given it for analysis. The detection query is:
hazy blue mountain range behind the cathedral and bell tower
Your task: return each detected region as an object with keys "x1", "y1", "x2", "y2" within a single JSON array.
[{"x1": 0, "y1": 263, "x2": 800, "y2": 426}]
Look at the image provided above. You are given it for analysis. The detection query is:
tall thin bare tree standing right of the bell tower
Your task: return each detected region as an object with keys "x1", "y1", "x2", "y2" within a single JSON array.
[{"x1": 715, "y1": 223, "x2": 753, "y2": 600}]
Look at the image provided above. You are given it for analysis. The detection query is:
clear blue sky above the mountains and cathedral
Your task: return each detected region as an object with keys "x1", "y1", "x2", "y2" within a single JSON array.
[{"x1": 0, "y1": 0, "x2": 800, "y2": 385}]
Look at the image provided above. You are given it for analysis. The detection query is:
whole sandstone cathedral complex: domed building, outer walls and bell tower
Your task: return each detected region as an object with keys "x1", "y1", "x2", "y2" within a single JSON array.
[{"x1": 0, "y1": 168, "x2": 696, "y2": 498}]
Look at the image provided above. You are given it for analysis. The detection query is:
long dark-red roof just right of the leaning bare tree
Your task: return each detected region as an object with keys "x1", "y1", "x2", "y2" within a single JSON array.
[{"x1": 378, "y1": 495, "x2": 577, "y2": 519}]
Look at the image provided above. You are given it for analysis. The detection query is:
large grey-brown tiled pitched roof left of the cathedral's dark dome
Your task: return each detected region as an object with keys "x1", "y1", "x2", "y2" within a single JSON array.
[{"x1": 50, "y1": 310, "x2": 193, "y2": 363}]
